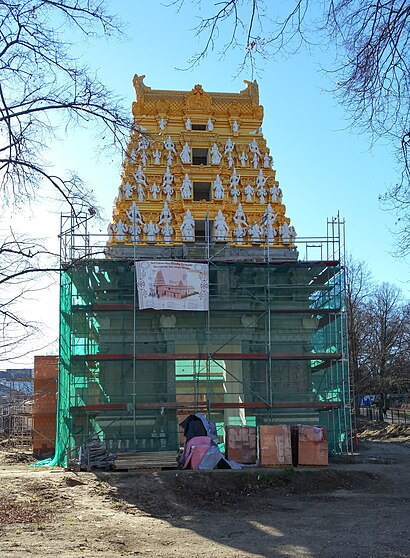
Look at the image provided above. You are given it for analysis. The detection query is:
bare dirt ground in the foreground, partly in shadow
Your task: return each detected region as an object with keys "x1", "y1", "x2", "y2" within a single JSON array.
[{"x1": 0, "y1": 425, "x2": 410, "y2": 558}]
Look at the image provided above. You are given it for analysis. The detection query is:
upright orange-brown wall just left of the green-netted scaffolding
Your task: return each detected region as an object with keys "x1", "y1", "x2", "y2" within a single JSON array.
[{"x1": 33, "y1": 356, "x2": 58, "y2": 457}]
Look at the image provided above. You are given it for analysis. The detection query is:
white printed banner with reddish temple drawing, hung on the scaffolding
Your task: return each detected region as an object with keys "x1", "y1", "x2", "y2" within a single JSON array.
[{"x1": 135, "y1": 261, "x2": 209, "y2": 311}]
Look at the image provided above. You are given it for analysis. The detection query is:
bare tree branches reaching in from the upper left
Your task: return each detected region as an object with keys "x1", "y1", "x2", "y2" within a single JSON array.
[{"x1": 0, "y1": 0, "x2": 131, "y2": 210}]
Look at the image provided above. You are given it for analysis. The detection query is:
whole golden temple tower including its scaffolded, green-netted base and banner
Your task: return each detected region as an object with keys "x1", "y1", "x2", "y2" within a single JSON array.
[{"x1": 55, "y1": 76, "x2": 352, "y2": 463}]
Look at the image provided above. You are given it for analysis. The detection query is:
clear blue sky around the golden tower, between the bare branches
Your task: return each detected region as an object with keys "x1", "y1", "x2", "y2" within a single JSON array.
[{"x1": 3, "y1": 0, "x2": 409, "y2": 366}]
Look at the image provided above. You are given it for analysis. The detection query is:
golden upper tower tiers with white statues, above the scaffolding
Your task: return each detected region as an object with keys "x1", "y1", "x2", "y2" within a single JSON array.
[{"x1": 109, "y1": 75, "x2": 297, "y2": 259}]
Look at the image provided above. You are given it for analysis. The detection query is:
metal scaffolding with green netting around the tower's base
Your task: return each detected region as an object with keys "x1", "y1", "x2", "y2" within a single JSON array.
[{"x1": 55, "y1": 216, "x2": 352, "y2": 463}]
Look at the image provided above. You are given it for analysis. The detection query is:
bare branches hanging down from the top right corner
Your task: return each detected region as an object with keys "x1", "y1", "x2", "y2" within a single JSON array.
[{"x1": 171, "y1": 0, "x2": 410, "y2": 248}]
